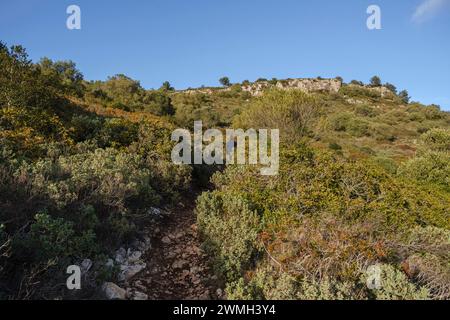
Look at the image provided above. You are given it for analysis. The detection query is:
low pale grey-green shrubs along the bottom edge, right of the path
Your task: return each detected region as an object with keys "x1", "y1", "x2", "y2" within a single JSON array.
[{"x1": 227, "y1": 264, "x2": 429, "y2": 300}]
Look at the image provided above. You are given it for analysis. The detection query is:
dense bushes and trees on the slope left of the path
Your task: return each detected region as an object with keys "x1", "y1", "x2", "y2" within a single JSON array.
[{"x1": 0, "y1": 45, "x2": 191, "y2": 299}]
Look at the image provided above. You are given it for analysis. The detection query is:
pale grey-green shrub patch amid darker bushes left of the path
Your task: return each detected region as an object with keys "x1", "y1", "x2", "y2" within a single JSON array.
[{"x1": 18, "y1": 149, "x2": 158, "y2": 210}]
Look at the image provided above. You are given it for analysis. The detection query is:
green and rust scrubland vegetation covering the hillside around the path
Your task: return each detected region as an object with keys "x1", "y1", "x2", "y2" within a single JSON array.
[{"x1": 0, "y1": 41, "x2": 450, "y2": 299}]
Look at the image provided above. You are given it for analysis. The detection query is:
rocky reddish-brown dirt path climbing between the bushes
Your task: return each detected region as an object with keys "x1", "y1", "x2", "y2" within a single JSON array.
[{"x1": 133, "y1": 200, "x2": 222, "y2": 300}]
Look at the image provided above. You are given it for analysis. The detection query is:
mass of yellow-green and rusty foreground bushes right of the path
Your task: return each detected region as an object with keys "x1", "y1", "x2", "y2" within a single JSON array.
[{"x1": 197, "y1": 146, "x2": 450, "y2": 299}]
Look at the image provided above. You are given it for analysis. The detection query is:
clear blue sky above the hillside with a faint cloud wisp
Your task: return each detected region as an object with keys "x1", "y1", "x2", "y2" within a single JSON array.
[{"x1": 0, "y1": 0, "x2": 450, "y2": 110}]
